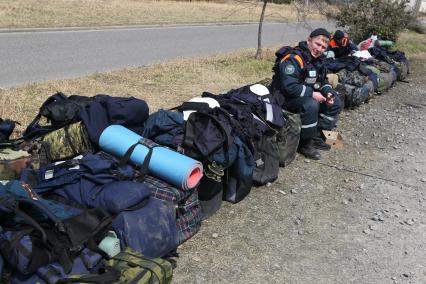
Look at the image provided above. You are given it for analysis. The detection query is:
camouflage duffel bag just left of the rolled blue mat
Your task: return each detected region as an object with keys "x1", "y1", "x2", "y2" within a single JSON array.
[{"x1": 36, "y1": 122, "x2": 94, "y2": 163}]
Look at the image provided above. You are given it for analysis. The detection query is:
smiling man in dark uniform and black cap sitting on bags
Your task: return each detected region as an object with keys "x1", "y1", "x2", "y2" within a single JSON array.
[{"x1": 272, "y1": 28, "x2": 341, "y2": 160}]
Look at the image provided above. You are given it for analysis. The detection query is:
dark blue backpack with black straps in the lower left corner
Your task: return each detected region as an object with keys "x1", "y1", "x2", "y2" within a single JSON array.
[{"x1": 0, "y1": 180, "x2": 111, "y2": 275}]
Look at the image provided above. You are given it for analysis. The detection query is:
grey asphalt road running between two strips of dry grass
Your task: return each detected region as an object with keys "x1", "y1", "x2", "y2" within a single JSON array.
[{"x1": 0, "y1": 22, "x2": 333, "y2": 87}]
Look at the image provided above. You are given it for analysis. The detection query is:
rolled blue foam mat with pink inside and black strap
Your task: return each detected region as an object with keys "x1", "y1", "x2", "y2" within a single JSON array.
[{"x1": 99, "y1": 125, "x2": 203, "y2": 190}]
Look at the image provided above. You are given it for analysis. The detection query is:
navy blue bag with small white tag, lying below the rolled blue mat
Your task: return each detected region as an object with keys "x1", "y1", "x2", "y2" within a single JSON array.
[{"x1": 21, "y1": 153, "x2": 149, "y2": 214}]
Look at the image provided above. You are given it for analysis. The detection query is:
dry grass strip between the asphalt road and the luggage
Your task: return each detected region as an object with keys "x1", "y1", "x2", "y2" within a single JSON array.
[{"x1": 0, "y1": 49, "x2": 274, "y2": 131}]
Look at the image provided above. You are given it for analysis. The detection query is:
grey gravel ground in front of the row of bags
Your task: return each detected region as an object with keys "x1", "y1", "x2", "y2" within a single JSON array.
[{"x1": 174, "y1": 58, "x2": 426, "y2": 283}]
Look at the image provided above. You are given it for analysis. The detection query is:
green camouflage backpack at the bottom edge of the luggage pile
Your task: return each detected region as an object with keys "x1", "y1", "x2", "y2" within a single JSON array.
[{"x1": 57, "y1": 247, "x2": 173, "y2": 284}]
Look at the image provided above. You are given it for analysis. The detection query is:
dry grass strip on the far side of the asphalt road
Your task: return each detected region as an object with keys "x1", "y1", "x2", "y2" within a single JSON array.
[{"x1": 0, "y1": 0, "x2": 320, "y2": 28}]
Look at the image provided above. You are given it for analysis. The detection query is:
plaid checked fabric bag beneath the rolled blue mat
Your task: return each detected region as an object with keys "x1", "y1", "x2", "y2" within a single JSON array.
[{"x1": 142, "y1": 175, "x2": 202, "y2": 244}]
